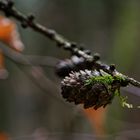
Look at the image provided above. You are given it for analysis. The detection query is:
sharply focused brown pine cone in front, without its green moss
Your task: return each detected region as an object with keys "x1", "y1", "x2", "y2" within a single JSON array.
[{"x1": 61, "y1": 70, "x2": 114, "y2": 109}]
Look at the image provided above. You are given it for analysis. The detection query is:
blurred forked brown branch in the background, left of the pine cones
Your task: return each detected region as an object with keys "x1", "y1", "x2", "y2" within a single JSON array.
[{"x1": 0, "y1": 45, "x2": 71, "y2": 107}]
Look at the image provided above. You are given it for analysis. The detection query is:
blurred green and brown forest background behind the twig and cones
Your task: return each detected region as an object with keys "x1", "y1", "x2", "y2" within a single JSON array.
[{"x1": 0, "y1": 0, "x2": 140, "y2": 140}]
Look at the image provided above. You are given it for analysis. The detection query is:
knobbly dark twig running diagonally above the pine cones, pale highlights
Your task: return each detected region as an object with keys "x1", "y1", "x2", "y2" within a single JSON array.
[{"x1": 0, "y1": 0, "x2": 140, "y2": 88}]
